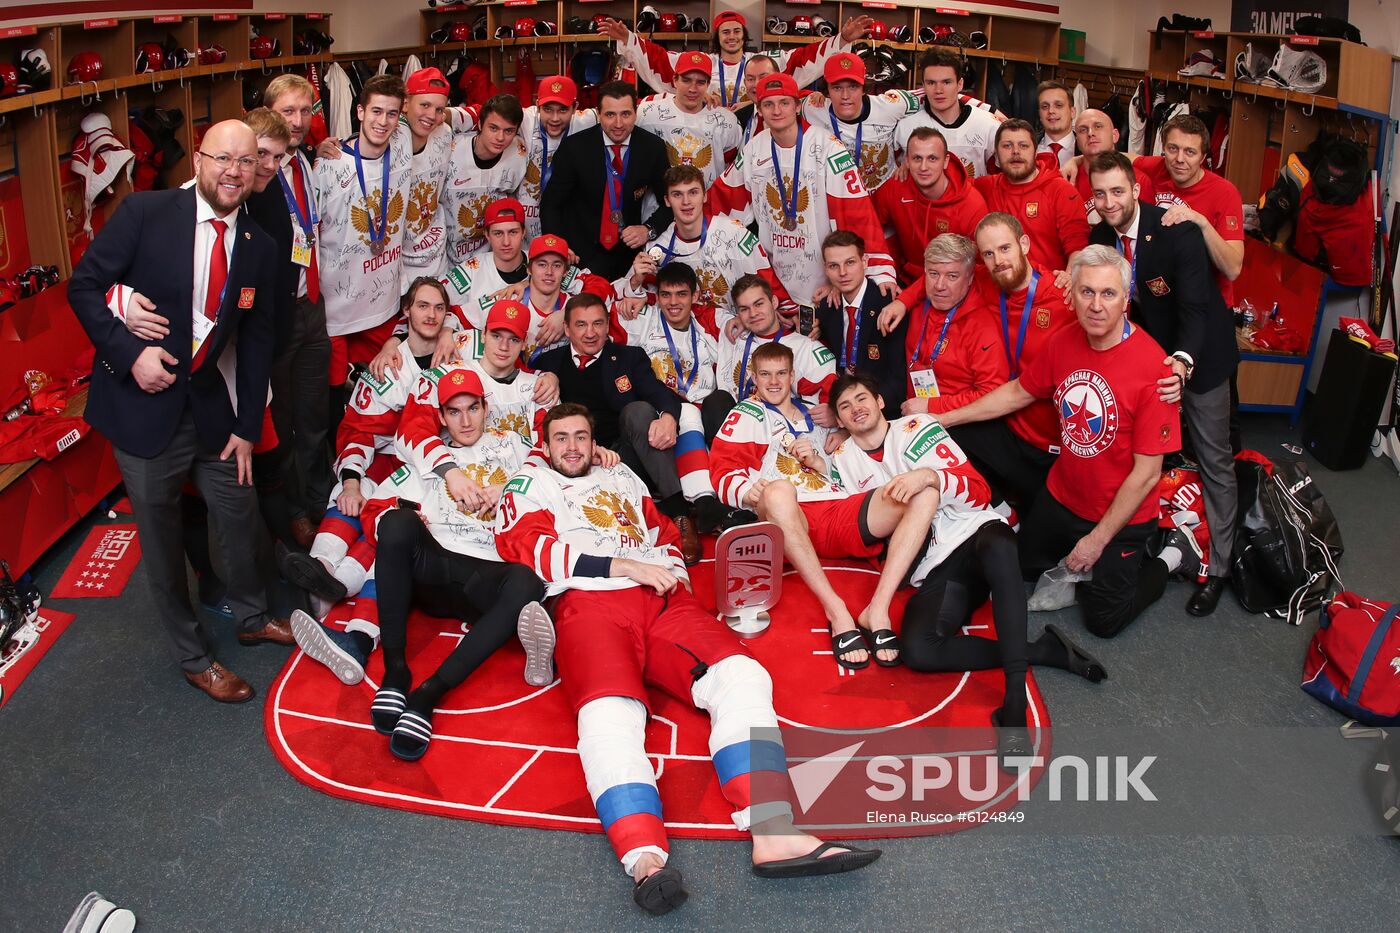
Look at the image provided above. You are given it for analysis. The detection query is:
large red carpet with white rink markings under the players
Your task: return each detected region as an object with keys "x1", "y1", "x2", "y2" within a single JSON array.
[{"x1": 265, "y1": 551, "x2": 1050, "y2": 839}]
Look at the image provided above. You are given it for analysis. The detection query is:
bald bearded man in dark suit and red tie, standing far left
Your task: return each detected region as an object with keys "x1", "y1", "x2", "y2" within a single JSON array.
[{"x1": 69, "y1": 120, "x2": 293, "y2": 702}]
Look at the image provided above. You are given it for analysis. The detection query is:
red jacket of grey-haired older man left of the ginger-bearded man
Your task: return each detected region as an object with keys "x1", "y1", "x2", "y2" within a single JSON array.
[{"x1": 899, "y1": 276, "x2": 1008, "y2": 415}]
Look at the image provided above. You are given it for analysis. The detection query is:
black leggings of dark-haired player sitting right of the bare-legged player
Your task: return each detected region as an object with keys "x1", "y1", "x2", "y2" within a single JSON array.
[{"x1": 900, "y1": 521, "x2": 1029, "y2": 721}]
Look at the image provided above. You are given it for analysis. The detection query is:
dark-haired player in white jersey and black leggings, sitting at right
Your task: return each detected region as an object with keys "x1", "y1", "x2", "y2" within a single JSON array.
[{"x1": 832, "y1": 374, "x2": 1106, "y2": 758}]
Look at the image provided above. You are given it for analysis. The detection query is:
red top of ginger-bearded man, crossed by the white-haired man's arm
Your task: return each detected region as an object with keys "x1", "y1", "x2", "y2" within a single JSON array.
[{"x1": 974, "y1": 263, "x2": 1075, "y2": 450}]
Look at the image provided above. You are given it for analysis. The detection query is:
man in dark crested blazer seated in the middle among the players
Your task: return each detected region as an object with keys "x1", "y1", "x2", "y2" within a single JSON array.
[{"x1": 535, "y1": 291, "x2": 720, "y2": 563}]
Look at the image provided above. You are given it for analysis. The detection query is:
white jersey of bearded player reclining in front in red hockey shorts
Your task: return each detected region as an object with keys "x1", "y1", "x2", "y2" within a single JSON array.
[{"x1": 496, "y1": 462, "x2": 690, "y2": 595}]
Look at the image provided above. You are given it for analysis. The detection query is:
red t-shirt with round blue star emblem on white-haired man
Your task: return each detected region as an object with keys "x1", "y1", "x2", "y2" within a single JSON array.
[{"x1": 1021, "y1": 326, "x2": 1182, "y2": 525}]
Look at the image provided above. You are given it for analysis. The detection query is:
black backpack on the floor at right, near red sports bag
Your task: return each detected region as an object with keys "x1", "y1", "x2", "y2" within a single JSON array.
[{"x1": 1231, "y1": 459, "x2": 1343, "y2": 625}]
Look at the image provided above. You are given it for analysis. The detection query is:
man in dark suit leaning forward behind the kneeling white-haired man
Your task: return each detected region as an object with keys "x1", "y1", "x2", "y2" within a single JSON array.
[{"x1": 1088, "y1": 151, "x2": 1239, "y2": 615}]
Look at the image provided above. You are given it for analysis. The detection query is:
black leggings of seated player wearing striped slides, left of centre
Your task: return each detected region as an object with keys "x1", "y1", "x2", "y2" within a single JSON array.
[{"x1": 374, "y1": 509, "x2": 545, "y2": 709}]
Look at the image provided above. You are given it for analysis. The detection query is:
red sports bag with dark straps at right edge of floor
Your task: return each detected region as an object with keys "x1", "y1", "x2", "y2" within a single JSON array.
[{"x1": 1303, "y1": 593, "x2": 1400, "y2": 726}]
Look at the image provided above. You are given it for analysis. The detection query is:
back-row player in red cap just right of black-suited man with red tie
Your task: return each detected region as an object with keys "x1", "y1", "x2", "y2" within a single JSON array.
[{"x1": 637, "y1": 52, "x2": 743, "y2": 186}]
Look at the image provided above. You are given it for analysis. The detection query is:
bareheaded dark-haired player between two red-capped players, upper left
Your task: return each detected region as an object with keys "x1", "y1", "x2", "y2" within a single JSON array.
[{"x1": 442, "y1": 94, "x2": 529, "y2": 265}]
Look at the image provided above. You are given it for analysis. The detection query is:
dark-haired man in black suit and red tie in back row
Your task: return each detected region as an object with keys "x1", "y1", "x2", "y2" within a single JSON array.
[{"x1": 539, "y1": 81, "x2": 671, "y2": 282}]
